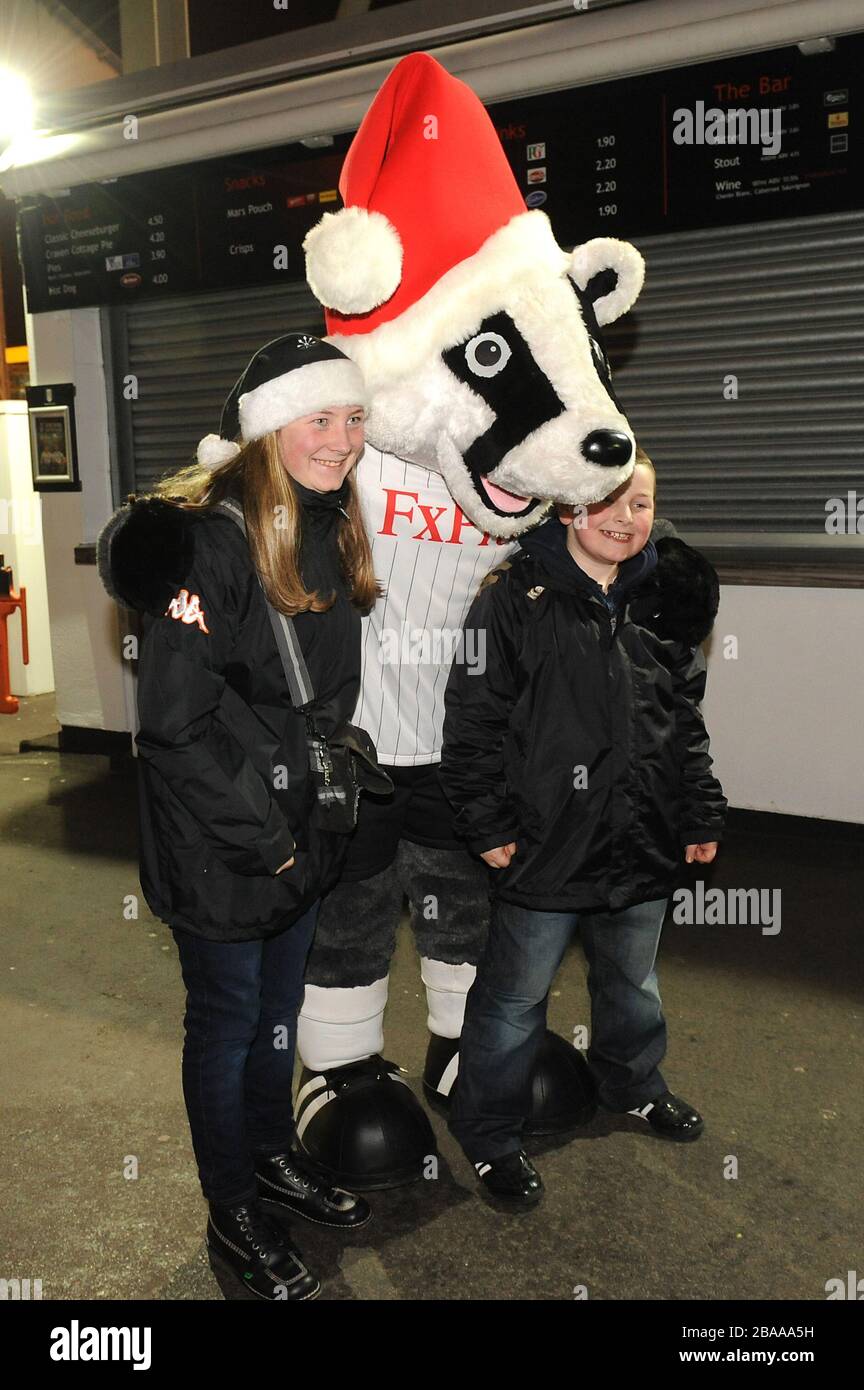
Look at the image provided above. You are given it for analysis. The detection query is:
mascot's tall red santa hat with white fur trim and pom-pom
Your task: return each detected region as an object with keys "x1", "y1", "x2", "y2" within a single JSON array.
[{"x1": 304, "y1": 53, "x2": 608, "y2": 385}]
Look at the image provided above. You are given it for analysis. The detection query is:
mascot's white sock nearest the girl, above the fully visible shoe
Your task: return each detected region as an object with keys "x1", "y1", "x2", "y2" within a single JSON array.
[{"x1": 297, "y1": 974, "x2": 388, "y2": 1072}]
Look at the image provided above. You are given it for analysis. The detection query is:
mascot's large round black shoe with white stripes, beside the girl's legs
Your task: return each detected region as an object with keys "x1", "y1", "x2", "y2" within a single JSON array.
[{"x1": 294, "y1": 1054, "x2": 438, "y2": 1193}]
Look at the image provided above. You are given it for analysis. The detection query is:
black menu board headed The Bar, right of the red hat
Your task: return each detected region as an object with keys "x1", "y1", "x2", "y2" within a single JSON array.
[{"x1": 490, "y1": 35, "x2": 864, "y2": 245}]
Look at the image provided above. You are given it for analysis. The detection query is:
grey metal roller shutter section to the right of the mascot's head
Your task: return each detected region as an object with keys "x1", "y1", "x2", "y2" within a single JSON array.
[{"x1": 606, "y1": 213, "x2": 864, "y2": 552}]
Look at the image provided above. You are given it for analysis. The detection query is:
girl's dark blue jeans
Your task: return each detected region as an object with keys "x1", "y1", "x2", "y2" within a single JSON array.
[{"x1": 174, "y1": 901, "x2": 321, "y2": 1207}]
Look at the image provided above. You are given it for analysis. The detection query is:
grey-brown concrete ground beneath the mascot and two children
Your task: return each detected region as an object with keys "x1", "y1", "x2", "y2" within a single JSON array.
[{"x1": 0, "y1": 696, "x2": 864, "y2": 1300}]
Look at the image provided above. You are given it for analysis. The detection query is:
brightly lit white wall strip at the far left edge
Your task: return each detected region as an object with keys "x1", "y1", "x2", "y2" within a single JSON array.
[{"x1": 0, "y1": 400, "x2": 54, "y2": 695}]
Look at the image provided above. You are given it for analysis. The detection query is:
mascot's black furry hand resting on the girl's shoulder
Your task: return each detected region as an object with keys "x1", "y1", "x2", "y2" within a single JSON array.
[{"x1": 96, "y1": 498, "x2": 201, "y2": 617}]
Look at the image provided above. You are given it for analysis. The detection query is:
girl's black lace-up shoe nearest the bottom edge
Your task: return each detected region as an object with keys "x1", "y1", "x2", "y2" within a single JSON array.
[{"x1": 207, "y1": 1198, "x2": 321, "y2": 1302}]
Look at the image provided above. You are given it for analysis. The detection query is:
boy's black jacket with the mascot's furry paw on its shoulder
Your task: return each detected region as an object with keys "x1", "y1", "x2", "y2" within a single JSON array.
[{"x1": 440, "y1": 516, "x2": 726, "y2": 912}]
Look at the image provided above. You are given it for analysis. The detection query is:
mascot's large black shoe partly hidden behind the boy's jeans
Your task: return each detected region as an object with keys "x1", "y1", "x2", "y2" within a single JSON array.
[{"x1": 424, "y1": 1029, "x2": 597, "y2": 1137}]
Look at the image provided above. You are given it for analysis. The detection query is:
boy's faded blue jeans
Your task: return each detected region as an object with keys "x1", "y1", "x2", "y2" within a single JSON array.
[{"x1": 450, "y1": 898, "x2": 668, "y2": 1163}]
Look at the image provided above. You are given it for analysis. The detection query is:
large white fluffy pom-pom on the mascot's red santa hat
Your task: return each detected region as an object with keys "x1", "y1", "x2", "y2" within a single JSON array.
[{"x1": 303, "y1": 207, "x2": 401, "y2": 314}]
